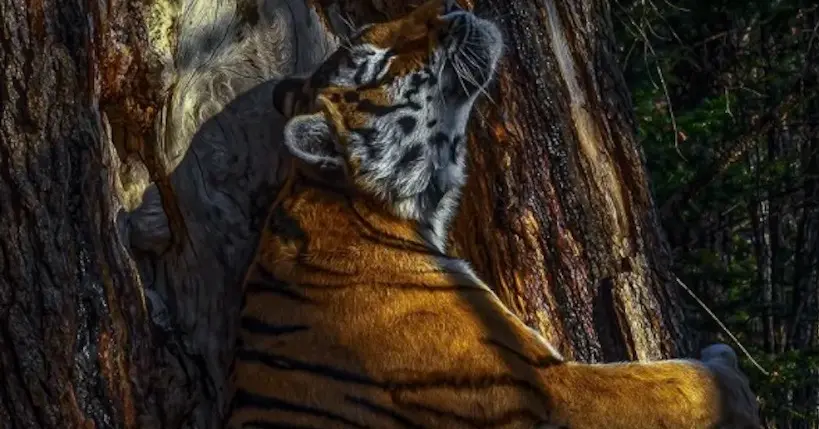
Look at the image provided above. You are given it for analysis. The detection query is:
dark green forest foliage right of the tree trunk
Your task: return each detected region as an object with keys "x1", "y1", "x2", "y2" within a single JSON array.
[{"x1": 612, "y1": 0, "x2": 819, "y2": 428}]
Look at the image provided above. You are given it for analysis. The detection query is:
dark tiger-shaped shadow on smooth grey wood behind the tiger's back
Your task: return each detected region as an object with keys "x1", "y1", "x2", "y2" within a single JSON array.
[{"x1": 128, "y1": 78, "x2": 294, "y2": 428}]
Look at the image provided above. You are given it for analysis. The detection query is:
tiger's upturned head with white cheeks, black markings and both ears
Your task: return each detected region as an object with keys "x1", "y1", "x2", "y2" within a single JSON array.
[{"x1": 273, "y1": 0, "x2": 503, "y2": 248}]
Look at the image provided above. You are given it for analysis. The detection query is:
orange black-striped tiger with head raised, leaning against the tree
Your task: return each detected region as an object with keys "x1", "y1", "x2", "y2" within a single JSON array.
[{"x1": 225, "y1": 0, "x2": 761, "y2": 429}]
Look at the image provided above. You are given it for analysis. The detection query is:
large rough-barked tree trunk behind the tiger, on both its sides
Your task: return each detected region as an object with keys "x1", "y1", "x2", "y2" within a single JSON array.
[{"x1": 0, "y1": 0, "x2": 689, "y2": 428}]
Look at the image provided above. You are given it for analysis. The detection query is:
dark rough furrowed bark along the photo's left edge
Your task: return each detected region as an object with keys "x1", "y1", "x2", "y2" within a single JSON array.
[{"x1": 0, "y1": 0, "x2": 187, "y2": 429}]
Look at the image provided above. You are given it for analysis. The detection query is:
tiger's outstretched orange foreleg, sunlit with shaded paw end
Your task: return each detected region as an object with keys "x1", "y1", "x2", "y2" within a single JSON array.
[{"x1": 542, "y1": 344, "x2": 762, "y2": 429}]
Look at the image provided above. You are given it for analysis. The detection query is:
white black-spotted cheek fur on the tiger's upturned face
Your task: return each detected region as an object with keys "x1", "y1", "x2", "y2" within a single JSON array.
[{"x1": 320, "y1": 67, "x2": 471, "y2": 231}]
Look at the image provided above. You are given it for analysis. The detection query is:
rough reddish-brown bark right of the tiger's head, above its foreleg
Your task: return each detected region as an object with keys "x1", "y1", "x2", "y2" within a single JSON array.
[{"x1": 314, "y1": 0, "x2": 691, "y2": 361}]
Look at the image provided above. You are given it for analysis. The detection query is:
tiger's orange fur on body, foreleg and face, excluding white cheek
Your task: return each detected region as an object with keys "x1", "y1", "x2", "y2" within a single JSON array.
[{"x1": 228, "y1": 0, "x2": 758, "y2": 429}]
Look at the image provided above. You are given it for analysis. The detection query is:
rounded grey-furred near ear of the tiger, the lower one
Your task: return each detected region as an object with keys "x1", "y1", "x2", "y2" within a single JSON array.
[{"x1": 284, "y1": 111, "x2": 344, "y2": 170}]
